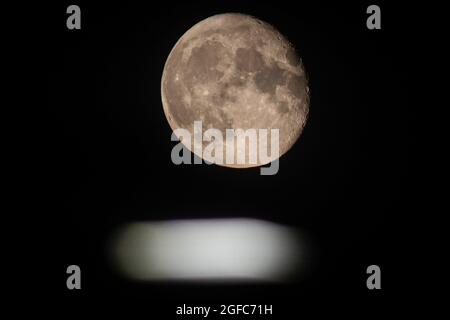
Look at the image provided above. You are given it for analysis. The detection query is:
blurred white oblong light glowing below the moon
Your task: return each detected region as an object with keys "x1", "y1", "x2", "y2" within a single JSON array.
[{"x1": 112, "y1": 219, "x2": 303, "y2": 281}]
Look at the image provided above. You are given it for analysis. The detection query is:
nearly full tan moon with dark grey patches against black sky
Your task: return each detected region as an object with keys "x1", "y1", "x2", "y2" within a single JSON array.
[{"x1": 161, "y1": 14, "x2": 309, "y2": 168}]
